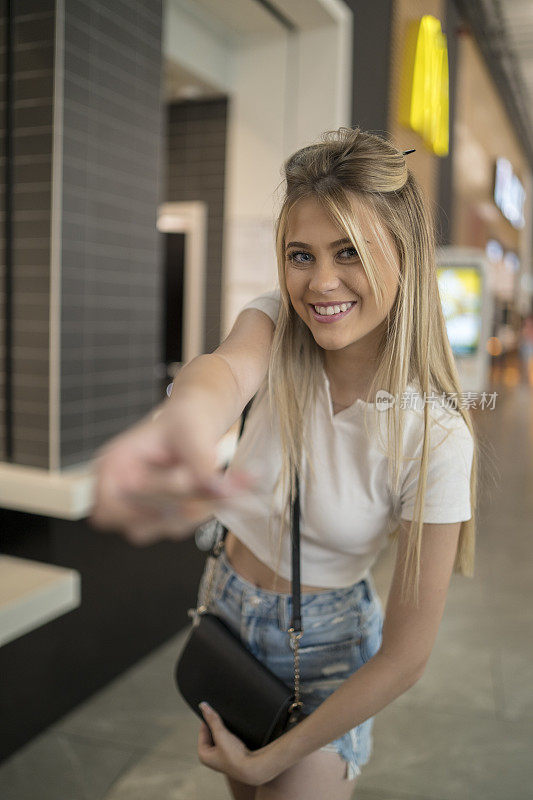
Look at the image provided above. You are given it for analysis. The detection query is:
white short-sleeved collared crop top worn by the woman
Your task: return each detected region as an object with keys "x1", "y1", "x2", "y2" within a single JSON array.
[{"x1": 215, "y1": 289, "x2": 473, "y2": 588}]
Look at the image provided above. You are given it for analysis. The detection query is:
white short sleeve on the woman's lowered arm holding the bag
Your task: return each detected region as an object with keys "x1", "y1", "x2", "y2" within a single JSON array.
[{"x1": 399, "y1": 417, "x2": 474, "y2": 523}]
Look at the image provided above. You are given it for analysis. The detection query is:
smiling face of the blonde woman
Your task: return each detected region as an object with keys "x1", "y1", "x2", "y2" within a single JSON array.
[{"x1": 285, "y1": 195, "x2": 400, "y2": 355}]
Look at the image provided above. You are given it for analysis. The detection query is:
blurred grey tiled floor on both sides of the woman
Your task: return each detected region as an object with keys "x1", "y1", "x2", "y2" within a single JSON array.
[{"x1": 0, "y1": 386, "x2": 533, "y2": 800}]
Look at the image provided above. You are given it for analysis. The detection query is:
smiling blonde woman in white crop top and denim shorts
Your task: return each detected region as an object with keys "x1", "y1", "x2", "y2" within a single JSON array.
[{"x1": 92, "y1": 128, "x2": 477, "y2": 800}]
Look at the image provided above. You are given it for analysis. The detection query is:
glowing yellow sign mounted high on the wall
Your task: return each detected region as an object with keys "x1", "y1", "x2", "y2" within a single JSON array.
[{"x1": 399, "y1": 14, "x2": 449, "y2": 156}]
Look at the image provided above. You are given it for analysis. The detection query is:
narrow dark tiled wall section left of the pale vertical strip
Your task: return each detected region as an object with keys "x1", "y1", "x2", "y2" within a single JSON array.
[{"x1": 0, "y1": 0, "x2": 55, "y2": 467}]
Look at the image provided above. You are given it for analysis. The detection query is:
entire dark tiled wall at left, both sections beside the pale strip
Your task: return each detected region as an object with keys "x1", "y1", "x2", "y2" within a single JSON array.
[{"x1": 0, "y1": 0, "x2": 162, "y2": 469}]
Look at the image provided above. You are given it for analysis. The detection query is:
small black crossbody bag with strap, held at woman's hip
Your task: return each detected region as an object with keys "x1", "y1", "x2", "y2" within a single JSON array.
[{"x1": 175, "y1": 398, "x2": 308, "y2": 750}]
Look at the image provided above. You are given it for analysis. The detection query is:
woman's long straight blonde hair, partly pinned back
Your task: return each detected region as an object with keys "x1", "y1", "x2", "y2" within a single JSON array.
[{"x1": 267, "y1": 127, "x2": 478, "y2": 605}]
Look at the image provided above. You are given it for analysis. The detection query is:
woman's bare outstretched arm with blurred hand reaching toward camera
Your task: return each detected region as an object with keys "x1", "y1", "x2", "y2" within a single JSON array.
[{"x1": 89, "y1": 308, "x2": 274, "y2": 545}]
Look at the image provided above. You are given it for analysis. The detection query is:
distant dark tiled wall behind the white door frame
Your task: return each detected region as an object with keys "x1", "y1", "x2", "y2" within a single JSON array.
[{"x1": 165, "y1": 98, "x2": 228, "y2": 353}]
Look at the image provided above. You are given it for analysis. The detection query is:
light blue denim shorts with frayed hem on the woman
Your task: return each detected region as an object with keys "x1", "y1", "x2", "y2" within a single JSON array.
[{"x1": 198, "y1": 550, "x2": 383, "y2": 780}]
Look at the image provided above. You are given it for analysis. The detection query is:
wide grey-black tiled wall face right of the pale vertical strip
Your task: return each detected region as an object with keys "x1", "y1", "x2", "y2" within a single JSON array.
[{"x1": 61, "y1": 0, "x2": 162, "y2": 467}]
